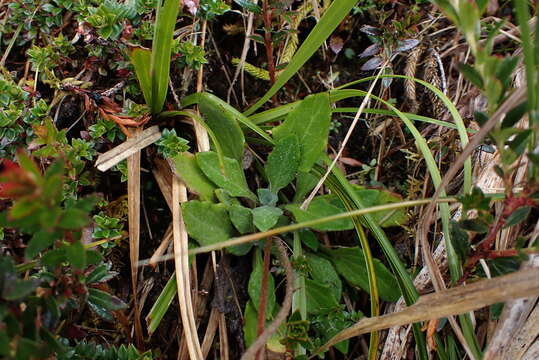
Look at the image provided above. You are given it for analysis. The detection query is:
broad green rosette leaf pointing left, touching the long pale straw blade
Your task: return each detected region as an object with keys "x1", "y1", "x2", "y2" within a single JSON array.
[{"x1": 182, "y1": 200, "x2": 234, "y2": 246}]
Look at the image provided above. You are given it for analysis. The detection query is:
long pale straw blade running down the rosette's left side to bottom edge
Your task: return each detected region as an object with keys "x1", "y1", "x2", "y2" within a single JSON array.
[{"x1": 172, "y1": 176, "x2": 203, "y2": 360}]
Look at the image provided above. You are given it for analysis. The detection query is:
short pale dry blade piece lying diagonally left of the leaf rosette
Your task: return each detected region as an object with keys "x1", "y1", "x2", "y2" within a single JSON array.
[{"x1": 95, "y1": 125, "x2": 161, "y2": 171}]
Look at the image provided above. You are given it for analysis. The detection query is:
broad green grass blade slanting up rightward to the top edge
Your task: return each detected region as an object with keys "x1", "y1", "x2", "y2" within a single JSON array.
[{"x1": 244, "y1": 0, "x2": 357, "y2": 116}]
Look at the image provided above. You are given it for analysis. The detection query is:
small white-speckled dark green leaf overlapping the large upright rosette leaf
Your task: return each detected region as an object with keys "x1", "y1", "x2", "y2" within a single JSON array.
[{"x1": 265, "y1": 134, "x2": 301, "y2": 193}]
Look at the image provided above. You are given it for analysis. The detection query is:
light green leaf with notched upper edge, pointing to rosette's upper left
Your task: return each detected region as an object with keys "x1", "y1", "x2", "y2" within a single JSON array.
[{"x1": 195, "y1": 151, "x2": 256, "y2": 200}]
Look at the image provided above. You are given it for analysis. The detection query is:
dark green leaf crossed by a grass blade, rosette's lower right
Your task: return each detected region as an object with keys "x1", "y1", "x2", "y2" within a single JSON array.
[{"x1": 327, "y1": 247, "x2": 401, "y2": 301}]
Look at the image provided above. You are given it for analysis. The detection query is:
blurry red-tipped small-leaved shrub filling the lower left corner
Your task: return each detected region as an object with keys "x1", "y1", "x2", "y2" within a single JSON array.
[{"x1": 0, "y1": 157, "x2": 126, "y2": 360}]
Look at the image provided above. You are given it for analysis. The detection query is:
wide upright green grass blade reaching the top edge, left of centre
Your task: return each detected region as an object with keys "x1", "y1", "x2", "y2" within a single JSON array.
[{"x1": 150, "y1": 0, "x2": 180, "y2": 114}]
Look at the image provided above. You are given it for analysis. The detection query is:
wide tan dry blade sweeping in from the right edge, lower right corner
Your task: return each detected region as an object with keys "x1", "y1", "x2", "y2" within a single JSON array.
[{"x1": 320, "y1": 269, "x2": 539, "y2": 351}]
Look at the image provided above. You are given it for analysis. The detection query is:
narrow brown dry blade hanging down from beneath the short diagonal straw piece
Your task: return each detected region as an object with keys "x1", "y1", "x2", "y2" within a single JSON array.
[{"x1": 127, "y1": 134, "x2": 142, "y2": 347}]
